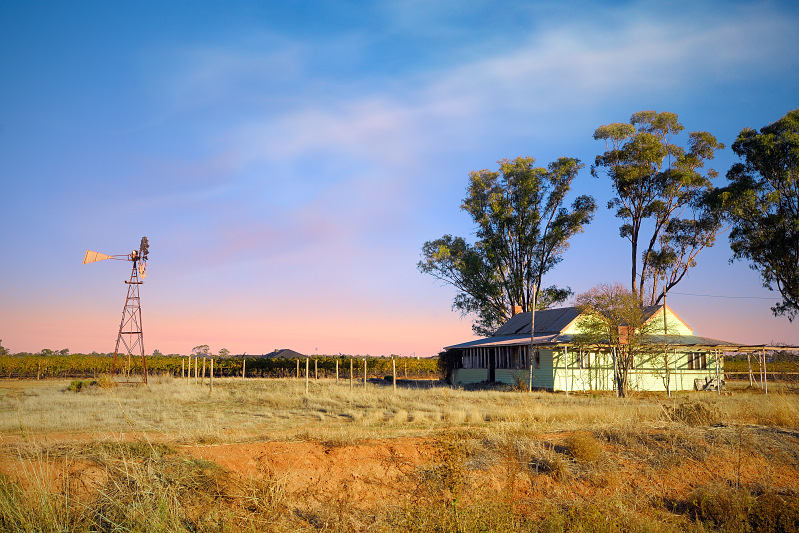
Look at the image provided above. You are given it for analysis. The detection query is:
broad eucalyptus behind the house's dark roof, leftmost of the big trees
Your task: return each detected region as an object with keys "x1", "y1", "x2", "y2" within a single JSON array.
[{"x1": 417, "y1": 157, "x2": 596, "y2": 335}]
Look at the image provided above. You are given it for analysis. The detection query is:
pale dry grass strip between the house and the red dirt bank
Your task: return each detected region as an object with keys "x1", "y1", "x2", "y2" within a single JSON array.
[{"x1": 0, "y1": 377, "x2": 799, "y2": 443}]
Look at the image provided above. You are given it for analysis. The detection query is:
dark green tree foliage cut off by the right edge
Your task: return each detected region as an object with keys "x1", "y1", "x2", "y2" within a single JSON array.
[{"x1": 722, "y1": 109, "x2": 799, "y2": 320}]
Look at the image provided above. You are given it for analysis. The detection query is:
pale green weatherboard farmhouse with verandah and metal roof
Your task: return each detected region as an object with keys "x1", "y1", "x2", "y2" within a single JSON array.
[{"x1": 445, "y1": 305, "x2": 763, "y2": 391}]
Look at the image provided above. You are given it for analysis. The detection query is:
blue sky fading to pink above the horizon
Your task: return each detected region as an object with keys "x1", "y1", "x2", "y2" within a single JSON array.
[{"x1": 0, "y1": 0, "x2": 799, "y2": 356}]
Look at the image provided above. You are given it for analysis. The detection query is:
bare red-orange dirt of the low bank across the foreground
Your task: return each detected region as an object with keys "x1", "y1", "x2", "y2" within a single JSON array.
[{"x1": 0, "y1": 428, "x2": 799, "y2": 507}]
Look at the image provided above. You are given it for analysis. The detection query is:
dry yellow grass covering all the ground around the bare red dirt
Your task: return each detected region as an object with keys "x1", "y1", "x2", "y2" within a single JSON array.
[{"x1": 0, "y1": 378, "x2": 799, "y2": 532}]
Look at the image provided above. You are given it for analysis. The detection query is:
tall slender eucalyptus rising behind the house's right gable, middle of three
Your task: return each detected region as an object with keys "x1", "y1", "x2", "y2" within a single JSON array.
[{"x1": 591, "y1": 111, "x2": 724, "y2": 304}]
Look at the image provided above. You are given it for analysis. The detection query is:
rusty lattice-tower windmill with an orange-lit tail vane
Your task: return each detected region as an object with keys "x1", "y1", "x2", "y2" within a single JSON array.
[{"x1": 83, "y1": 237, "x2": 150, "y2": 385}]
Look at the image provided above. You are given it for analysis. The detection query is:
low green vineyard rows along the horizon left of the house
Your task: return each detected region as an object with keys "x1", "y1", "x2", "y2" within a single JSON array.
[{"x1": 0, "y1": 354, "x2": 438, "y2": 379}]
